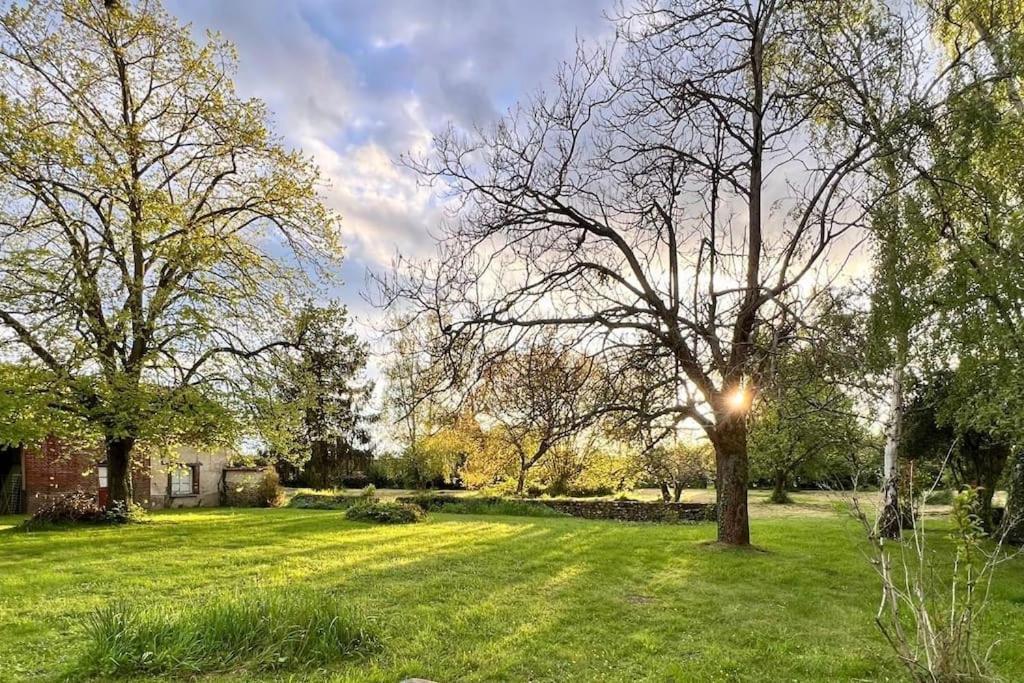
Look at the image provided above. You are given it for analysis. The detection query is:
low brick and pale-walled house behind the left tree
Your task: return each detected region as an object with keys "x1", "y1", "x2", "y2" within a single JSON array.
[{"x1": 0, "y1": 437, "x2": 257, "y2": 514}]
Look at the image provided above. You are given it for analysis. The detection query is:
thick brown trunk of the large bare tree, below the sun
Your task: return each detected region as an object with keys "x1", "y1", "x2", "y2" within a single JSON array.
[{"x1": 713, "y1": 415, "x2": 751, "y2": 546}]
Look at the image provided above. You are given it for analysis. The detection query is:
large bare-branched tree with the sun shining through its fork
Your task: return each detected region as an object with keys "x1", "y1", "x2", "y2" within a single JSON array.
[{"x1": 386, "y1": 0, "x2": 921, "y2": 545}]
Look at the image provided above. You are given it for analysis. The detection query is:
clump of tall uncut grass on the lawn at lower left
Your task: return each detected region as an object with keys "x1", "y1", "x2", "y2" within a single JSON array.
[{"x1": 80, "y1": 591, "x2": 380, "y2": 677}]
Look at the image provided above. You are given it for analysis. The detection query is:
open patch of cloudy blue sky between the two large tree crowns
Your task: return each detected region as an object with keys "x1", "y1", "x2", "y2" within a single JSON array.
[{"x1": 167, "y1": 0, "x2": 612, "y2": 327}]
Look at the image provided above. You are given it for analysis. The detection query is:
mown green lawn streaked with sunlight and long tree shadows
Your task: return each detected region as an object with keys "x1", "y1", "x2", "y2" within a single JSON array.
[{"x1": 0, "y1": 498, "x2": 1024, "y2": 683}]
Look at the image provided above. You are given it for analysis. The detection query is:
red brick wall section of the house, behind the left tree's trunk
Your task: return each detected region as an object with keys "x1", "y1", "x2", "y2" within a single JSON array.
[{"x1": 22, "y1": 437, "x2": 150, "y2": 514}]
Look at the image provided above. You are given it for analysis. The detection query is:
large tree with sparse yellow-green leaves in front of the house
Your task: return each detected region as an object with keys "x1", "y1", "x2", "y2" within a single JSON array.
[{"x1": 0, "y1": 0, "x2": 340, "y2": 501}]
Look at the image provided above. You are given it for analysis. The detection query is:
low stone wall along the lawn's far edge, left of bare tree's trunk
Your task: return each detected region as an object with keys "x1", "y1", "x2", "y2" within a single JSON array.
[{"x1": 398, "y1": 494, "x2": 716, "y2": 523}]
